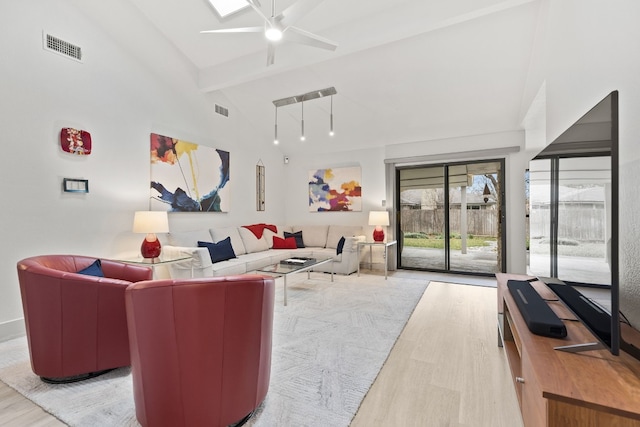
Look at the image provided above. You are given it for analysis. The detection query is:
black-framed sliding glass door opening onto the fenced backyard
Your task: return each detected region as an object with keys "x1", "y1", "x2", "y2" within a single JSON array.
[{"x1": 396, "y1": 160, "x2": 504, "y2": 274}]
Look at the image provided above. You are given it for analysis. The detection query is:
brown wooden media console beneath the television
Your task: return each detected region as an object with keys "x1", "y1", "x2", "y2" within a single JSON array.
[{"x1": 496, "y1": 273, "x2": 640, "y2": 427}]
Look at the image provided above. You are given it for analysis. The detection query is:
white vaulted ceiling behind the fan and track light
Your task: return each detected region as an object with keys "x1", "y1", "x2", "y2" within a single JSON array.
[{"x1": 76, "y1": 0, "x2": 539, "y2": 154}]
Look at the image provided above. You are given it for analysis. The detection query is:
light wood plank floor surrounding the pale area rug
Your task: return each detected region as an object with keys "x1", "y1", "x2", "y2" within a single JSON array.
[{"x1": 0, "y1": 272, "x2": 522, "y2": 427}]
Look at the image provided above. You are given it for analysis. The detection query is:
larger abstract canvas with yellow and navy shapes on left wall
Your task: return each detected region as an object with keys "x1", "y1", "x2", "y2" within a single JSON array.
[{"x1": 151, "y1": 133, "x2": 229, "y2": 212}]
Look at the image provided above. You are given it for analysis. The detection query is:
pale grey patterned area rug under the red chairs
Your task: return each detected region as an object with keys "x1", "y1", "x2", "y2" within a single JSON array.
[{"x1": 0, "y1": 273, "x2": 427, "y2": 426}]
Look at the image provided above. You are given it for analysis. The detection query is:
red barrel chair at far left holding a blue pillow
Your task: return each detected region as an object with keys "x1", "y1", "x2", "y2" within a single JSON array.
[{"x1": 17, "y1": 255, "x2": 152, "y2": 383}]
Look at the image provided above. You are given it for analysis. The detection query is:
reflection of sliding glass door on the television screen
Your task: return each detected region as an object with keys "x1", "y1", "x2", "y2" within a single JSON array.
[{"x1": 528, "y1": 156, "x2": 613, "y2": 285}]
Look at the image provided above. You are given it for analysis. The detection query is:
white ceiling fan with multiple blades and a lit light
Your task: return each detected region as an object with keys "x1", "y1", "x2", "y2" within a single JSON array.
[{"x1": 200, "y1": 0, "x2": 338, "y2": 66}]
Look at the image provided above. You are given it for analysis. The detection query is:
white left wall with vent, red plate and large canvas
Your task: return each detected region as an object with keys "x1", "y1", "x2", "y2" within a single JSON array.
[{"x1": 0, "y1": 0, "x2": 285, "y2": 340}]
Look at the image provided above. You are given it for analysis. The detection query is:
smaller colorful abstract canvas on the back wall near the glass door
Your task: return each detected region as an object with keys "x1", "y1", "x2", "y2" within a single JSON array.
[{"x1": 309, "y1": 167, "x2": 362, "y2": 212}]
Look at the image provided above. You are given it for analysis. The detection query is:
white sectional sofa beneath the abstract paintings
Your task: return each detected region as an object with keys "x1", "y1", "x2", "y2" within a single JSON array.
[{"x1": 162, "y1": 225, "x2": 365, "y2": 278}]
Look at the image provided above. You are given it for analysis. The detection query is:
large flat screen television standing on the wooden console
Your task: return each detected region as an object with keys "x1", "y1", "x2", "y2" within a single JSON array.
[{"x1": 527, "y1": 91, "x2": 640, "y2": 359}]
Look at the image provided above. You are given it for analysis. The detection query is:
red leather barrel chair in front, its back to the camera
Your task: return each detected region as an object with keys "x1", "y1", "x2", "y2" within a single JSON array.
[{"x1": 125, "y1": 275, "x2": 275, "y2": 427}]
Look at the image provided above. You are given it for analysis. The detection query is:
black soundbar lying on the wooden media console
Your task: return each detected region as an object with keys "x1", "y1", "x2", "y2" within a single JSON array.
[{"x1": 507, "y1": 280, "x2": 567, "y2": 338}]
